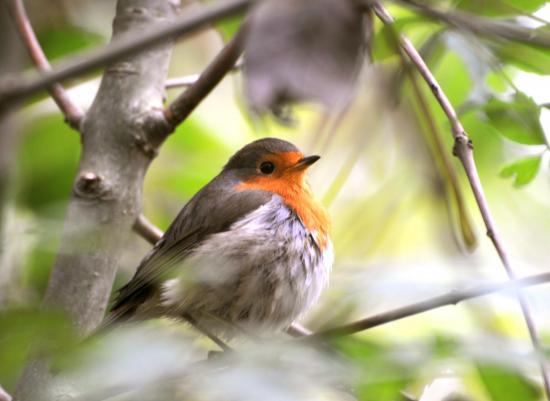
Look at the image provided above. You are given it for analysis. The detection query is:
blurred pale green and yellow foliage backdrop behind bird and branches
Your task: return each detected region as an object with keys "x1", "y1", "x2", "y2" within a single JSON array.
[{"x1": 0, "y1": 0, "x2": 550, "y2": 401}]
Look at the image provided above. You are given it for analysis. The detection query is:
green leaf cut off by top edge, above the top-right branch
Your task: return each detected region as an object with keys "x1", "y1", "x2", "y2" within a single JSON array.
[{"x1": 456, "y1": 0, "x2": 546, "y2": 17}]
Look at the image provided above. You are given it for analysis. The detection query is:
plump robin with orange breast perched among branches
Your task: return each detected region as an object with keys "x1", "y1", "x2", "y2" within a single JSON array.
[{"x1": 107, "y1": 138, "x2": 334, "y2": 338}]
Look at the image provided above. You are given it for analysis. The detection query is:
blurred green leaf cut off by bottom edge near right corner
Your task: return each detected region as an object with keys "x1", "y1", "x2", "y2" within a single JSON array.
[{"x1": 477, "y1": 363, "x2": 540, "y2": 401}]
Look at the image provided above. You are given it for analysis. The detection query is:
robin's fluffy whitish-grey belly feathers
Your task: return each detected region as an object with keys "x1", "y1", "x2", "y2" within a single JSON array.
[{"x1": 158, "y1": 195, "x2": 334, "y2": 333}]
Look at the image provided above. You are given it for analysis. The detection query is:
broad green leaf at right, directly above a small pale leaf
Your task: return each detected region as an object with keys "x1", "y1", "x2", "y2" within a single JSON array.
[{"x1": 484, "y1": 93, "x2": 546, "y2": 145}]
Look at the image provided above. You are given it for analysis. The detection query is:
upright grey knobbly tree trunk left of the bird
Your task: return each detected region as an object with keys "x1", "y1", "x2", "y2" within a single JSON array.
[{"x1": 16, "y1": 0, "x2": 178, "y2": 400}]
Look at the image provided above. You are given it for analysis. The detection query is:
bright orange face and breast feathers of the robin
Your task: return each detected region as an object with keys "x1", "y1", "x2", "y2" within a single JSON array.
[{"x1": 236, "y1": 152, "x2": 330, "y2": 250}]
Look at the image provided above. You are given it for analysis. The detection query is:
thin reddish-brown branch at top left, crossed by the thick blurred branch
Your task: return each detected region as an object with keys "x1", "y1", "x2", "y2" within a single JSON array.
[{"x1": 10, "y1": 0, "x2": 84, "y2": 131}]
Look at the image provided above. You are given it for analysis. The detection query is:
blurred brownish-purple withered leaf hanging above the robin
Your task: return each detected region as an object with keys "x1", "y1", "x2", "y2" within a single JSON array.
[{"x1": 244, "y1": 0, "x2": 368, "y2": 115}]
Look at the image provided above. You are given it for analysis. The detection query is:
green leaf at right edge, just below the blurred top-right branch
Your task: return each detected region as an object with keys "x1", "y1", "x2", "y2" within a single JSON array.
[{"x1": 496, "y1": 42, "x2": 550, "y2": 75}]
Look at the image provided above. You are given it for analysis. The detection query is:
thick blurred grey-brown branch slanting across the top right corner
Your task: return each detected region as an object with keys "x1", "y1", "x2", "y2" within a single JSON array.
[{"x1": 398, "y1": 0, "x2": 550, "y2": 48}]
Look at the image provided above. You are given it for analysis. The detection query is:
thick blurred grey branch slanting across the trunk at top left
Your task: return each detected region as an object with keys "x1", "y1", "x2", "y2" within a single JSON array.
[{"x1": 0, "y1": 0, "x2": 254, "y2": 109}]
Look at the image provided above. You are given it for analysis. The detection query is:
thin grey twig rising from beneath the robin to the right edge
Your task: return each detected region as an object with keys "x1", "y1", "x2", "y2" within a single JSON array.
[{"x1": 306, "y1": 272, "x2": 550, "y2": 339}]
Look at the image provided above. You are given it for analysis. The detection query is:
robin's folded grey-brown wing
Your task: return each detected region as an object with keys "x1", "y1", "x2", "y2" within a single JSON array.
[{"x1": 112, "y1": 176, "x2": 273, "y2": 314}]
